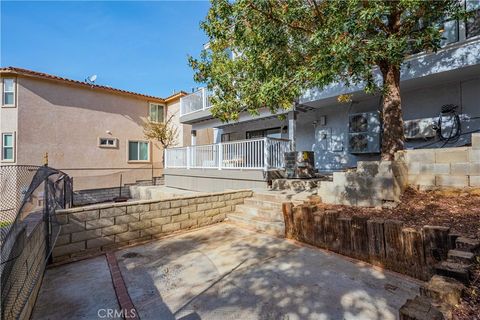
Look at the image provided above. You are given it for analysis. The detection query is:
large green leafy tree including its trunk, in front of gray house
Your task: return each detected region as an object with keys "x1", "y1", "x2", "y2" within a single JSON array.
[{"x1": 189, "y1": 0, "x2": 463, "y2": 159}]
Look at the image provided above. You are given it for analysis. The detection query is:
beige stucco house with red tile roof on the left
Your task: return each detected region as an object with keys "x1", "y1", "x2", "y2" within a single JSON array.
[{"x1": 0, "y1": 67, "x2": 213, "y2": 190}]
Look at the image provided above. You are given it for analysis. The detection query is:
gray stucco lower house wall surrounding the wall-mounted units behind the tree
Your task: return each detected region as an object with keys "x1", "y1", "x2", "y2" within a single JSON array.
[{"x1": 297, "y1": 77, "x2": 480, "y2": 170}]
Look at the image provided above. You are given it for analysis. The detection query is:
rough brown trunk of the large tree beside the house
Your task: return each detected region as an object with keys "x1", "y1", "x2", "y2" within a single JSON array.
[{"x1": 380, "y1": 65, "x2": 405, "y2": 160}]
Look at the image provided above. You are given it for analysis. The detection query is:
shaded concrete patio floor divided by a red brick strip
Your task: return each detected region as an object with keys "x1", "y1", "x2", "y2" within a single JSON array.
[{"x1": 33, "y1": 223, "x2": 420, "y2": 320}]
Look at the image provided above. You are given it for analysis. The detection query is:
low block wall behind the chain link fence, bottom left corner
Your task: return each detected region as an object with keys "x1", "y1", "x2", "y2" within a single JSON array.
[{"x1": 2, "y1": 214, "x2": 47, "y2": 320}]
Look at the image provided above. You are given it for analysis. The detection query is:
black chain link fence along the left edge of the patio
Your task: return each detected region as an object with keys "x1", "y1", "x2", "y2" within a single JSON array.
[{"x1": 0, "y1": 165, "x2": 73, "y2": 319}]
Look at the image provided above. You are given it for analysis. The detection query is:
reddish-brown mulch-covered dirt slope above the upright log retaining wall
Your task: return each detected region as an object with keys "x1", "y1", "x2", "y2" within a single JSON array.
[{"x1": 318, "y1": 188, "x2": 480, "y2": 237}]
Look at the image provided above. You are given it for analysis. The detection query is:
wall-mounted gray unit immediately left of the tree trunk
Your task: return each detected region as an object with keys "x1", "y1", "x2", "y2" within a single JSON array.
[{"x1": 348, "y1": 112, "x2": 381, "y2": 154}]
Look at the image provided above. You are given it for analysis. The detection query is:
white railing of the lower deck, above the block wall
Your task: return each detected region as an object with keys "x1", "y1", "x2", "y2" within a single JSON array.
[{"x1": 165, "y1": 138, "x2": 291, "y2": 170}]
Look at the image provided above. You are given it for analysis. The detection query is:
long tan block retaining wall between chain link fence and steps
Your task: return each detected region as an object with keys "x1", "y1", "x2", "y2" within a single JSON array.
[{"x1": 53, "y1": 190, "x2": 252, "y2": 262}]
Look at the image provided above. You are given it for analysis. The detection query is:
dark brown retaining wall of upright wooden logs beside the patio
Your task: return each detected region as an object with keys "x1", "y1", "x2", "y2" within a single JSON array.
[{"x1": 283, "y1": 203, "x2": 458, "y2": 280}]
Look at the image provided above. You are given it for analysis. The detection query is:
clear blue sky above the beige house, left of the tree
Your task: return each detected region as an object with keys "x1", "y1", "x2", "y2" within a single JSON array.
[{"x1": 0, "y1": 0, "x2": 209, "y2": 97}]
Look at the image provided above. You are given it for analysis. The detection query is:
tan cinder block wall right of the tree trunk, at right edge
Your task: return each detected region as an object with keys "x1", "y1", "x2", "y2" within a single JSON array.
[{"x1": 396, "y1": 133, "x2": 480, "y2": 189}]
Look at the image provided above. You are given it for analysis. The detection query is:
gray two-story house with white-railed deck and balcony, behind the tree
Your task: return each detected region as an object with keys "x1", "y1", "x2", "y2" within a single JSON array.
[{"x1": 165, "y1": 1, "x2": 480, "y2": 190}]
